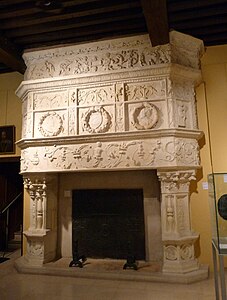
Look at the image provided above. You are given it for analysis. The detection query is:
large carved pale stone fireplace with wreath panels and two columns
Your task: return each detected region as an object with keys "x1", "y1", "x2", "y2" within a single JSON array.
[{"x1": 17, "y1": 31, "x2": 207, "y2": 282}]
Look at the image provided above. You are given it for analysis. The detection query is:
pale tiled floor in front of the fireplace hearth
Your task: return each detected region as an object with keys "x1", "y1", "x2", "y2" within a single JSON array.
[{"x1": 0, "y1": 253, "x2": 215, "y2": 300}]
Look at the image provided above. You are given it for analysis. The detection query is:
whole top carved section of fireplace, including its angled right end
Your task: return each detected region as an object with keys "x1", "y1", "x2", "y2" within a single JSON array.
[{"x1": 23, "y1": 31, "x2": 203, "y2": 80}]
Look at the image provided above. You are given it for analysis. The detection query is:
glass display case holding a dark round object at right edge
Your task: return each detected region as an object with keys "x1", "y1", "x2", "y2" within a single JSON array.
[{"x1": 208, "y1": 173, "x2": 227, "y2": 254}]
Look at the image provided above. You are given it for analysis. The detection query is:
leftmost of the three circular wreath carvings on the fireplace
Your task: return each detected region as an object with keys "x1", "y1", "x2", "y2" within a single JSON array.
[{"x1": 39, "y1": 112, "x2": 63, "y2": 137}]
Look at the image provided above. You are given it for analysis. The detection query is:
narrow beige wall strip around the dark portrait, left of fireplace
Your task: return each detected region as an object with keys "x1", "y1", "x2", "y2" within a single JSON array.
[{"x1": 0, "y1": 72, "x2": 23, "y2": 157}]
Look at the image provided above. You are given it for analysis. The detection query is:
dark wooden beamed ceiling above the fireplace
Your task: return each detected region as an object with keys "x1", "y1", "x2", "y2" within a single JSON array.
[{"x1": 0, "y1": 0, "x2": 227, "y2": 73}]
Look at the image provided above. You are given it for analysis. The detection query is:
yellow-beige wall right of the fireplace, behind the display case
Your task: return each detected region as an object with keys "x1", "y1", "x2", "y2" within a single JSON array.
[{"x1": 191, "y1": 45, "x2": 227, "y2": 269}]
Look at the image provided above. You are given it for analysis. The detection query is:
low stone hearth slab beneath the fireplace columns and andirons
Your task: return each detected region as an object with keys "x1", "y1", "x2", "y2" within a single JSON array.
[{"x1": 15, "y1": 257, "x2": 208, "y2": 283}]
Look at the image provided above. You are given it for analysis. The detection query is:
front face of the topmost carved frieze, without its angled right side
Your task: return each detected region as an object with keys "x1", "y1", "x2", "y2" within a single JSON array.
[{"x1": 24, "y1": 37, "x2": 171, "y2": 80}]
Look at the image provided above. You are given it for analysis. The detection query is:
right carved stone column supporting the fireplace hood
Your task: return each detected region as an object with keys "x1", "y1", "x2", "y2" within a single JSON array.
[{"x1": 158, "y1": 170, "x2": 199, "y2": 273}]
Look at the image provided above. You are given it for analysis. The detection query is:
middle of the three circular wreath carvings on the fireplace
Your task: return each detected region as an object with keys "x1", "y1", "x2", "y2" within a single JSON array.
[{"x1": 83, "y1": 107, "x2": 112, "y2": 133}]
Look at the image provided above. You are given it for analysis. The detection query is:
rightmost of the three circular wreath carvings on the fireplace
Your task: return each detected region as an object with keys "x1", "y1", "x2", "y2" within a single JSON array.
[{"x1": 132, "y1": 102, "x2": 158, "y2": 130}]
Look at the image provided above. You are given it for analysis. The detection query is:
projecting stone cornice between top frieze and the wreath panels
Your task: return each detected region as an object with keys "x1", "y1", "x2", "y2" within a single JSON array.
[{"x1": 16, "y1": 64, "x2": 201, "y2": 98}]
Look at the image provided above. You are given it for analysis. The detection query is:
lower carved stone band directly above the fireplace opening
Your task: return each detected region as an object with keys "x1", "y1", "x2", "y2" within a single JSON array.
[{"x1": 21, "y1": 136, "x2": 200, "y2": 174}]
